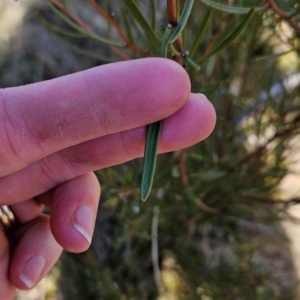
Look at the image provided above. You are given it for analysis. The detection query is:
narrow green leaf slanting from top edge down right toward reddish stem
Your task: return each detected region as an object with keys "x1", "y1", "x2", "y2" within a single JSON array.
[{"x1": 123, "y1": 0, "x2": 159, "y2": 43}]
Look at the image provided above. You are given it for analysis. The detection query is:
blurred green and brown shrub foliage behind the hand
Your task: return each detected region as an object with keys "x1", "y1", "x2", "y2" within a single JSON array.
[{"x1": 0, "y1": 0, "x2": 300, "y2": 300}]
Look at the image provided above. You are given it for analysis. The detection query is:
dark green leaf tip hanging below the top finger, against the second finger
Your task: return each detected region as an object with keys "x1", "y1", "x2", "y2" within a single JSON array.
[{"x1": 141, "y1": 121, "x2": 162, "y2": 201}]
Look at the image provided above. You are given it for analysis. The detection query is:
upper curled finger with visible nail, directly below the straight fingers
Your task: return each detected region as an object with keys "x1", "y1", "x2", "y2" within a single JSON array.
[{"x1": 37, "y1": 172, "x2": 100, "y2": 252}]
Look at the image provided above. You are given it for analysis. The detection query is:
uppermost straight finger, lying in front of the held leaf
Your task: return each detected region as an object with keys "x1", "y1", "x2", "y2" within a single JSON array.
[{"x1": 0, "y1": 58, "x2": 190, "y2": 176}]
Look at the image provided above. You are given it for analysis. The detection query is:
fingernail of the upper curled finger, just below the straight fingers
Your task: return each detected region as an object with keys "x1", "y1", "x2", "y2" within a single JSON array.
[{"x1": 73, "y1": 205, "x2": 94, "y2": 244}]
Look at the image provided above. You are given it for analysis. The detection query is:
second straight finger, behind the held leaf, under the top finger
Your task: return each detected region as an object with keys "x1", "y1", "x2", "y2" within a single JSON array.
[{"x1": 0, "y1": 95, "x2": 216, "y2": 204}]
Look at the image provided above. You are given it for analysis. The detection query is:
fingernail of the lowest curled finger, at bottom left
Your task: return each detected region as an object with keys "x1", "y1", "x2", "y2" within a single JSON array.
[{"x1": 20, "y1": 255, "x2": 46, "y2": 289}]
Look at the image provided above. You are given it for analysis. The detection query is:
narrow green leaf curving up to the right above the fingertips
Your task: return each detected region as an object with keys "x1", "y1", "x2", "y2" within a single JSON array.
[{"x1": 196, "y1": 7, "x2": 255, "y2": 63}]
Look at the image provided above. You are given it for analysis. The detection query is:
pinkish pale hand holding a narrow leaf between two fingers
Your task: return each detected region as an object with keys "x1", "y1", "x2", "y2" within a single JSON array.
[{"x1": 0, "y1": 58, "x2": 216, "y2": 300}]
